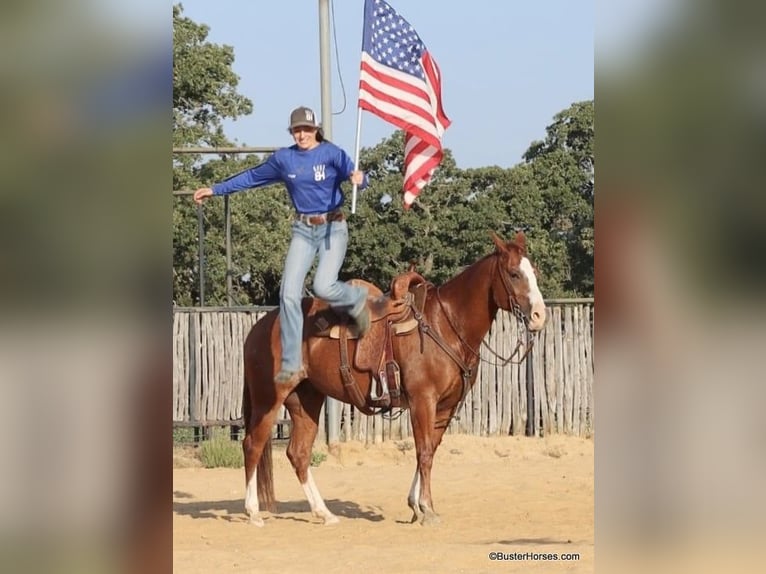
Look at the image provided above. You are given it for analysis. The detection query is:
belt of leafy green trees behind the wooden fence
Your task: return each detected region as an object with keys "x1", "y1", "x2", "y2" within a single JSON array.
[{"x1": 173, "y1": 5, "x2": 595, "y2": 305}]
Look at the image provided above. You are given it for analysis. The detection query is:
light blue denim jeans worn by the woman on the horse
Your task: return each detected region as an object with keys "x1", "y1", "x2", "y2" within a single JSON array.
[{"x1": 279, "y1": 221, "x2": 367, "y2": 371}]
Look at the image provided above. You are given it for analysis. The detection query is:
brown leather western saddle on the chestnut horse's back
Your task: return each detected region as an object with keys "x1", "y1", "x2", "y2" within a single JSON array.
[{"x1": 307, "y1": 270, "x2": 430, "y2": 414}]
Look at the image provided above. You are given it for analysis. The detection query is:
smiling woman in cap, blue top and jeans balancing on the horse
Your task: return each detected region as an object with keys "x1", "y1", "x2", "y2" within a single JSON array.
[{"x1": 194, "y1": 107, "x2": 370, "y2": 384}]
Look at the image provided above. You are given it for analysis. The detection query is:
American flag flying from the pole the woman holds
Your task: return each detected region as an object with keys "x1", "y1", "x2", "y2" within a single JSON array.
[{"x1": 359, "y1": 0, "x2": 451, "y2": 209}]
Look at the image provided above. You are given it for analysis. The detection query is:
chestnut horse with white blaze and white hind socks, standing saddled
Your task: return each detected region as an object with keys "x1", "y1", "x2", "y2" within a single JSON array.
[{"x1": 242, "y1": 232, "x2": 545, "y2": 526}]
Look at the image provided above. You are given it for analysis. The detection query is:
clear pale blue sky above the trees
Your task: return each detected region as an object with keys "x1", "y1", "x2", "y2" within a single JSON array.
[{"x1": 181, "y1": 0, "x2": 595, "y2": 169}]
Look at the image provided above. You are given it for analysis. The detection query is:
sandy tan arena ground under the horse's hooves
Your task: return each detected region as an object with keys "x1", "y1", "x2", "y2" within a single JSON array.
[{"x1": 173, "y1": 435, "x2": 594, "y2": 574}]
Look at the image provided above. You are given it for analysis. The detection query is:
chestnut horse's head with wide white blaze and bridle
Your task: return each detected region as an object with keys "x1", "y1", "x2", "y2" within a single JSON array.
[{"x1": 492, "y1": 231, "x2": 545, "y2": 331}]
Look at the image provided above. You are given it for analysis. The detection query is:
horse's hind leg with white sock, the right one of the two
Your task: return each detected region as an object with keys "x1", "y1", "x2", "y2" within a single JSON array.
[{"x1": 285, "y1": 388, "x2": 338, "y2": 524}]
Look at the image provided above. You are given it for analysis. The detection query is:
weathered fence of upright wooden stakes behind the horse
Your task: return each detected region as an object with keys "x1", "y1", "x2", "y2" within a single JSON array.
[{"x1": 173, "y1": 300, "x2": 594, "y2": 443}]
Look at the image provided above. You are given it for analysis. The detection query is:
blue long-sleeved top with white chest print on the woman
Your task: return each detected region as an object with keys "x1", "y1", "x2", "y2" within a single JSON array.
[{"x1": 212, "y1": 141, "x2": 368, "y2": 213}]
